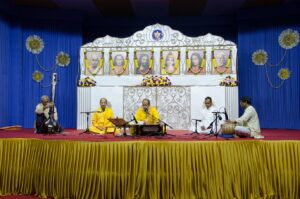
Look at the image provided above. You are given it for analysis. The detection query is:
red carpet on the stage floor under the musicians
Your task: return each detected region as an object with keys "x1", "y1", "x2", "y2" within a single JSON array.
[{"x1": 0, "y1": 129, "x2": 300, "y2": 142}]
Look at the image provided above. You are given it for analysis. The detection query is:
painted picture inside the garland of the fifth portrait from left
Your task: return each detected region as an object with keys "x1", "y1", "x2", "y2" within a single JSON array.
[{"x1": 187, "y1": 50, "x2": 205, "y2": 75}]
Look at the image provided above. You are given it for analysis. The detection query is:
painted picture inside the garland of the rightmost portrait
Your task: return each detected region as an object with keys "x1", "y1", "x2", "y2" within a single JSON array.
[{"x1": 213, "y1": 50, "x2": 232, "y2": 74}]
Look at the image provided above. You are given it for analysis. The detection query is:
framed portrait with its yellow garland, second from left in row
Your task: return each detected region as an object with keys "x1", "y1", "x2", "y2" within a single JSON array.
[{"x1": 109, "y1": 51, "x2": 129, "y2": 76}]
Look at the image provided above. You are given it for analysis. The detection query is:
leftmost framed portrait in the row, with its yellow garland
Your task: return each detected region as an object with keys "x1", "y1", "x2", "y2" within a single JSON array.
[{"x1": 84, "y1": 51, "x2": 103, "y2": 76}]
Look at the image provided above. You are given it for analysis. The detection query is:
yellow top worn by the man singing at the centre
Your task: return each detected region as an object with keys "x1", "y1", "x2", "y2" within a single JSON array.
[{"x1": 135, "y1": 106, "x2": 159, "y2": 124}]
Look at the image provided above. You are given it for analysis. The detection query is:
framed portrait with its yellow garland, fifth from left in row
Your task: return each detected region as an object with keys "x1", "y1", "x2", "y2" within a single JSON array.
[{"x1": 186, "y1": 50, "x2": 206, "y2": 75}]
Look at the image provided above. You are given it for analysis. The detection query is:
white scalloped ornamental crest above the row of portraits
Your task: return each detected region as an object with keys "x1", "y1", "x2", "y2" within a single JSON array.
[{"x1": 82, "y1": 24, "x2": 236, "y2": 49}]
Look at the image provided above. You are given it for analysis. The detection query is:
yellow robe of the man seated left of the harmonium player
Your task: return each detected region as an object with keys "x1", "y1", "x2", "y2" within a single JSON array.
[{"x1": 89, "y1": 107, "x2": 115, "y2": 134}]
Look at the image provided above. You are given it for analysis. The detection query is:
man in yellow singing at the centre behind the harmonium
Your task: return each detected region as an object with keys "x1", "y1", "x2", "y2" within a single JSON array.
[{"x1": 135, "y1": 99, "x2": 159, "y2": 124}]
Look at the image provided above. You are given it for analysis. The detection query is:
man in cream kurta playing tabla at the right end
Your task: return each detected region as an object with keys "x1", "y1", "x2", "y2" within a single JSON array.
[{"x1": 229, "y1": 97, "x2": 263, "y2": 139}]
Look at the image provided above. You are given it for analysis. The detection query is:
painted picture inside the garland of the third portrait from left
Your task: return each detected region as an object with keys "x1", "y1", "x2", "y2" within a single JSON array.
[{"x1": 135, "y1": 51, "x2": 153, "y2": 75}]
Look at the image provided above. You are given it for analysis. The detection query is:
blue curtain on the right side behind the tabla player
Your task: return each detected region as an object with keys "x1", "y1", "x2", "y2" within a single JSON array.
[{"x1": 238, "y1": 24, "x2": 300, "y2": 129}]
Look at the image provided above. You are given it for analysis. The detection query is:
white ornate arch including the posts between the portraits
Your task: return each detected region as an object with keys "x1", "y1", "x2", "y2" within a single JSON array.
[{"x1": 80, "y1": 24, "x2": 237, "y2": 77}]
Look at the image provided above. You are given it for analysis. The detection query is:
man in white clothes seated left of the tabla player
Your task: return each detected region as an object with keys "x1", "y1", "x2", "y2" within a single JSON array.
[{"x1": 191, "y1": 97, "x2": 216, "y2": 133}]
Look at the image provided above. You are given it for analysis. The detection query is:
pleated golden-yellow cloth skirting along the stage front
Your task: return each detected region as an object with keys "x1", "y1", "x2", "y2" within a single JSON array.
[{"x1": 0, "y1": 139, "x2": 300, "y2": 199}]
